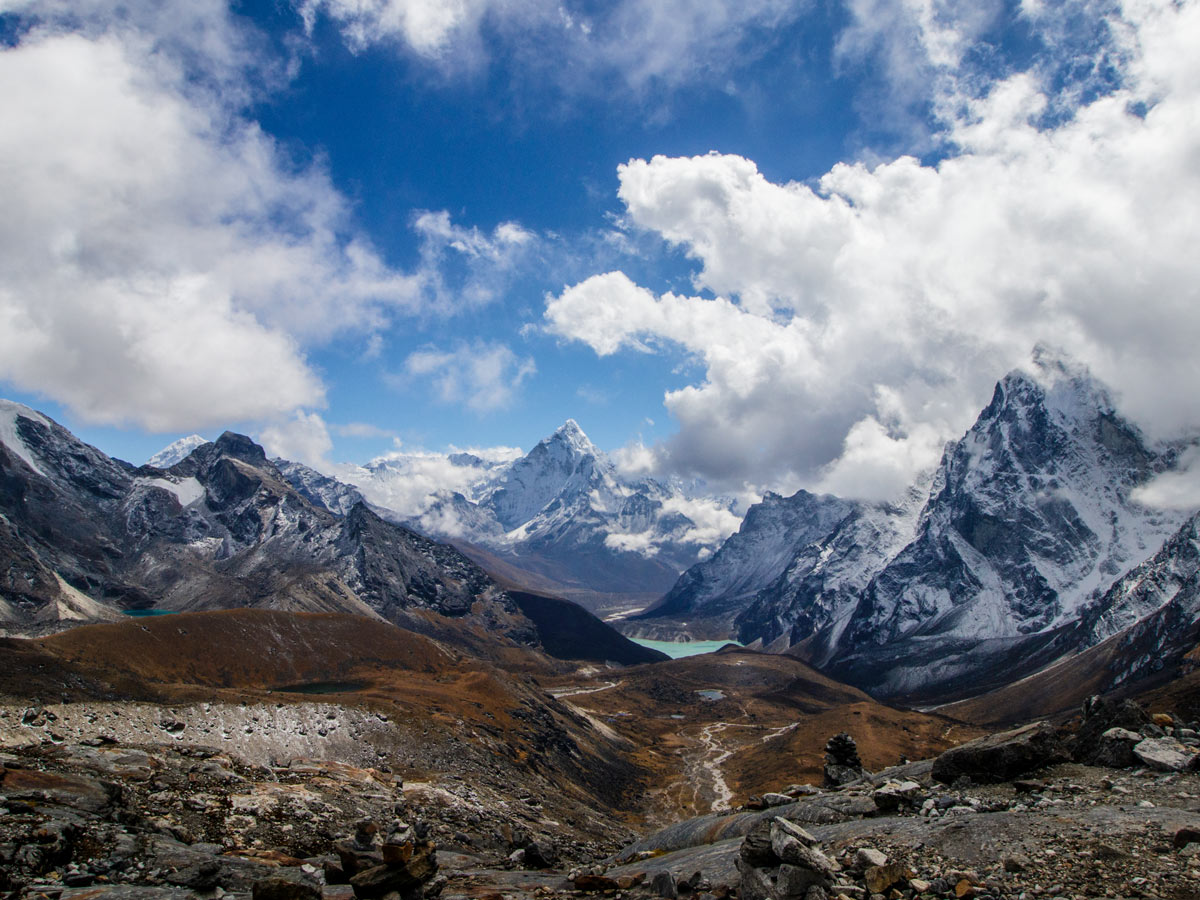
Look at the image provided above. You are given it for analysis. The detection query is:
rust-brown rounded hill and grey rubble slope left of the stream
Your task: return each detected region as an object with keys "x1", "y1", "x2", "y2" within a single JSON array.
[{"x1": 0, "y1": 610, "x2": 657, "y2": 898}]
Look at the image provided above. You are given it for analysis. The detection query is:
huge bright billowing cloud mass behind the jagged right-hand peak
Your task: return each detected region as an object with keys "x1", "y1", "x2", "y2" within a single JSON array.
[{"x1": 545, "y1": 0, "x2": 1200, "y2": 497}]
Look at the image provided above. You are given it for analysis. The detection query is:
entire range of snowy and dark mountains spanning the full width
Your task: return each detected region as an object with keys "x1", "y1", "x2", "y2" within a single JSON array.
[{"x1": 0, "y1": 345, "x2": 1200, "y2": 704}]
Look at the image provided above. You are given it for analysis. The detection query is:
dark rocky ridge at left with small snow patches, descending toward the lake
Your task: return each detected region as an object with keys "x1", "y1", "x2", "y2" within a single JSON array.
[{"x1": 0, "y1": 401, "x2": 659, "y2": 661}]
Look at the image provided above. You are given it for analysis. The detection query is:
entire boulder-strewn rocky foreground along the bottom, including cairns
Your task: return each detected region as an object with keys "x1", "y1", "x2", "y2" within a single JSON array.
[{"x1": 7, "y1": 702, "x2": 1200, "y2": 900}]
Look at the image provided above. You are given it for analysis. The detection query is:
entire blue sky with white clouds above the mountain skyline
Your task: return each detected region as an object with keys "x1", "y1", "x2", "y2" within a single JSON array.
[{"x1": 0, "y1": 0, "x2": 1200, "y2": 497}]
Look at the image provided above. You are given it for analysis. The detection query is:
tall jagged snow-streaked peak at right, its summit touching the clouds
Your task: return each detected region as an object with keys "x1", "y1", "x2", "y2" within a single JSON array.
[{"x1": 816, "y1": 366, "x2": 1180, "y2": 695}]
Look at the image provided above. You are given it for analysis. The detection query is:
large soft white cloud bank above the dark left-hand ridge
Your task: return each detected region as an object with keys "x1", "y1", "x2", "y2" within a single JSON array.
[{"x1": 0, "y1": 0, "x2": 535, "y2": 431}]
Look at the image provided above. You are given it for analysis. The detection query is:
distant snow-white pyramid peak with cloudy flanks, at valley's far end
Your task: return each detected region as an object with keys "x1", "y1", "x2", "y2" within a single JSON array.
[{"x1": 304, "y1": 420, "x2": 737, "y2": 611}]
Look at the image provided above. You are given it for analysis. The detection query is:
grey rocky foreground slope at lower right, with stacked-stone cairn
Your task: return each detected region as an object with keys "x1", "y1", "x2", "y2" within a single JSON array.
[{"x1": 604, "y1": 703, "x2": 1200, "y2": 900}]
